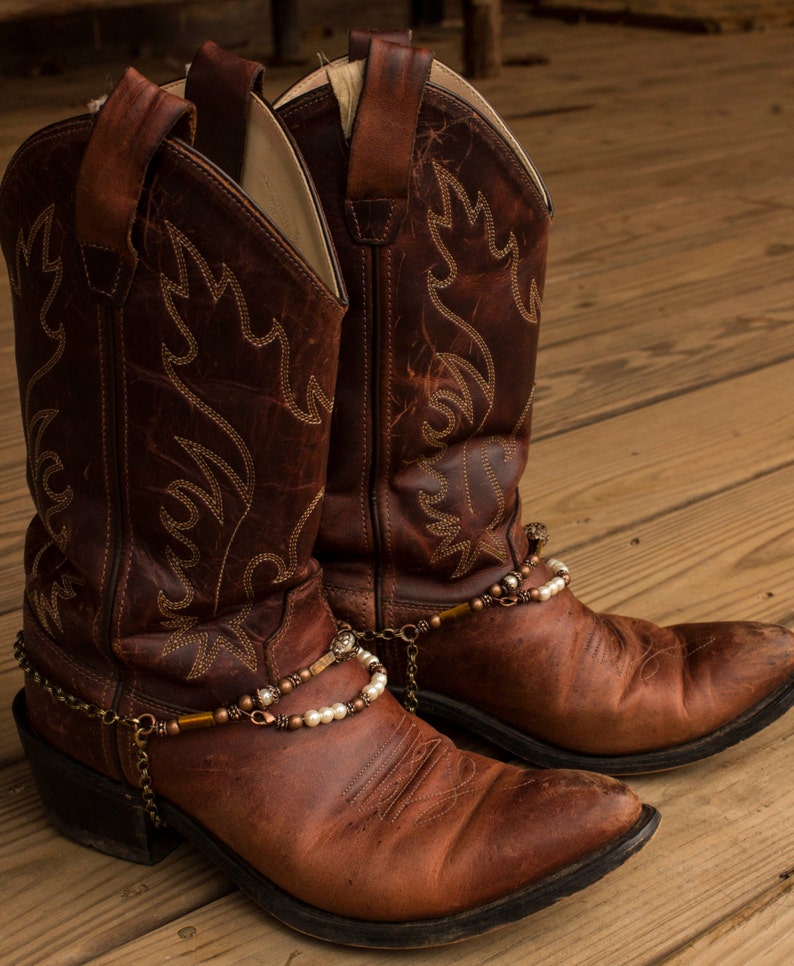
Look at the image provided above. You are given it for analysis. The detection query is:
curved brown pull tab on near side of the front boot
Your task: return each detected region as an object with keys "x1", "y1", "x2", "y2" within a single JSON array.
[{"x1": 75, "y1": 67, "x2": 195, "y2": 305}]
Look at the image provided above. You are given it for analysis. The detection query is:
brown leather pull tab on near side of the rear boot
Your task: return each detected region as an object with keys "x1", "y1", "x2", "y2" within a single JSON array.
[{"x1": 345, "y1": 36, "x2": 433, "y2": 245}]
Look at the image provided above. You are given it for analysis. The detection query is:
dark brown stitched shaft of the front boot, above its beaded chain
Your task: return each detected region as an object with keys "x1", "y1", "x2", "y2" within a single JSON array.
[{"x1": 0, "y1": 62, "x2": 343, "y2": 707}]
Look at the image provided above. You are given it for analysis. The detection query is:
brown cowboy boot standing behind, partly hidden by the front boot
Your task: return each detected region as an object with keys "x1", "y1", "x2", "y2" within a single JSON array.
[{"x1": 276, "y1": 33, "x2": 794, "y2": 774}]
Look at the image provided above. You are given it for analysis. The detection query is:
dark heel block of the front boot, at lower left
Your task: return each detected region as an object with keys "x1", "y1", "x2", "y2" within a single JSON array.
[{"x1": 13, "y1": 691, "x2": 182, "y2": 865}]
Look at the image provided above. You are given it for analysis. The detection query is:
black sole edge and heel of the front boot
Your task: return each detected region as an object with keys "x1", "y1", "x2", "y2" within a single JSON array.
[{"x1": 13, "y1": 691, "x2": 660, "y2": 949}]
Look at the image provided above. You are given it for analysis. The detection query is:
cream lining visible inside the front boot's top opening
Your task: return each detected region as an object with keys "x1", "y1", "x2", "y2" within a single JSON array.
[{"x1": 165, "y1": 80, "x2": 341, "y2": 296}]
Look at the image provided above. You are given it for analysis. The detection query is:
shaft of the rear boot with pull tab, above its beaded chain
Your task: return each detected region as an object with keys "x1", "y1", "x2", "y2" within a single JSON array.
[{"x1": 276, "y1": 39, "x2": 551, "y2": 626}]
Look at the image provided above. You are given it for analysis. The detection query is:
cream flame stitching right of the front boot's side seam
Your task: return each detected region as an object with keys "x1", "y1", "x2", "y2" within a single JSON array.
[{"x1": 158, "y1": 224, "x2": 325, "y2": 679}]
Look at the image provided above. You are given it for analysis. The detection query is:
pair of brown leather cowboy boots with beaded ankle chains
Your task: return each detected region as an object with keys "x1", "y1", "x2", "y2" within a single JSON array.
[{"x1": 0, "y1": 34, "x2": 794, "y2": 947}]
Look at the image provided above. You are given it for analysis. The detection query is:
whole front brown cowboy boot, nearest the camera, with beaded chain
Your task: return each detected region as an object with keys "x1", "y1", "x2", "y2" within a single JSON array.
[{"x1": 0, "y1": 51, "x2": 657, "y2": 947}]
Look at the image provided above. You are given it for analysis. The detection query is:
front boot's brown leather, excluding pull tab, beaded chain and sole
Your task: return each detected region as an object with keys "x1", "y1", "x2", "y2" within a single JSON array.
[{"x1": 0, "y1": 64, "x2": 641, "y2": 921}]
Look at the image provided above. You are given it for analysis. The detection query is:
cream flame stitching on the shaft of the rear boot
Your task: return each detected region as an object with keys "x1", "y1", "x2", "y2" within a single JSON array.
[{"x1": 419, "y1": 162, "x2": 541, "y2": 578}]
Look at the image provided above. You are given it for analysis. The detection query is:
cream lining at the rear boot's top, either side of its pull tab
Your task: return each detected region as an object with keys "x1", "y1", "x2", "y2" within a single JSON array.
[{"x1": 273, "y1": 57, "x2": 551, "y2": 211}]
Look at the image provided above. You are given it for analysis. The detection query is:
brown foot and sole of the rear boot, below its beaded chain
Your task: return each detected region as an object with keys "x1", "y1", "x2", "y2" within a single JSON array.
[{"x1": 390, "y1": 565, "x2": 794, "y2": 775}]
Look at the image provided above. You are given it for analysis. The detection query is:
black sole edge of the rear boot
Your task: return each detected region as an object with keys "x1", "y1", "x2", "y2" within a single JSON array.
[{"x1": 391, "y1": 681, "x2": 794, "y2": 777}]
